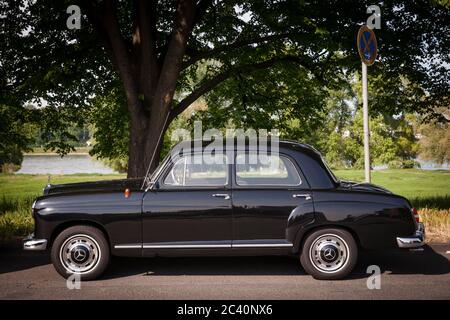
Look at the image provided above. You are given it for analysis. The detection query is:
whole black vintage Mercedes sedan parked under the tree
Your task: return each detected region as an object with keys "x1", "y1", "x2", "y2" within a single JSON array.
[{"x1": 23, "y1": 141, "x2": 424, "y2": 280}]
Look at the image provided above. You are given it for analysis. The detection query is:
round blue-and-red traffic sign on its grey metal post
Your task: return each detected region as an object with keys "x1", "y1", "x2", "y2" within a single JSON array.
[{"x1": 357, "y1": 26, "x2": 377, "y2": 183}]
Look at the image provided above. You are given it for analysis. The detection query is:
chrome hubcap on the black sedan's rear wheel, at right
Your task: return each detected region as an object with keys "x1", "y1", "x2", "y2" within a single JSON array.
[{"x1": 309, "y1": 234, "x2": 349, "y2": 273}]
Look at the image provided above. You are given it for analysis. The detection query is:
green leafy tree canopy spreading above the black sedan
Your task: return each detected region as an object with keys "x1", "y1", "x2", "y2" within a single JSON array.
[{"x1": 0, "y1": 0, "x2": 450, "y2": 172}]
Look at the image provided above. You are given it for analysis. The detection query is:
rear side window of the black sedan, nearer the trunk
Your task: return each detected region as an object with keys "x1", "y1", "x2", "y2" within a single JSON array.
[{"x1": 236, "y1": 153, "x2": 302, "y2": 186}]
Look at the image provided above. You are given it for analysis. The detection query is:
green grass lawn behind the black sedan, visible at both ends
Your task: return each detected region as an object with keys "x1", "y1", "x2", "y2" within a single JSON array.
[{"x1": 0, "y1": 169, "x2": 450, "y2": 242}]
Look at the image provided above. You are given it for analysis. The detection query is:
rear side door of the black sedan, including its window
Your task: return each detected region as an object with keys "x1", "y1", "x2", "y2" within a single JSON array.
[{"x1": 233, "y1": 153, "x2": 314, "y2": 248}]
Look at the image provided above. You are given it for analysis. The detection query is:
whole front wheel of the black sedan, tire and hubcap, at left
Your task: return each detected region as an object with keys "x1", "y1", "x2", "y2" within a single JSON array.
[{"x1": 51, "y1": 225, "x2": 110, "y2": 281}]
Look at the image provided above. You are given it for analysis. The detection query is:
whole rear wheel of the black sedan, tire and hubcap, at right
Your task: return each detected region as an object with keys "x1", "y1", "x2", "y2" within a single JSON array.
[{"x1": 300, "y1": 228, "x2": 358, "y2": 280}]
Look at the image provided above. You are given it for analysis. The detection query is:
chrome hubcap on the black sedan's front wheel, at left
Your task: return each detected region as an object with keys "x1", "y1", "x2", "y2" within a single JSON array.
[{"x1": 60, "y1": 234, "x2": 101, "y2": 274}]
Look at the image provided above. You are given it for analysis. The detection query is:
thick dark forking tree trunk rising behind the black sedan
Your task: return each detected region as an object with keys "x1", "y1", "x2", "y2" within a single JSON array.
[{"x1": 87, "y1": 0, "x2": 198, "y2": 178}]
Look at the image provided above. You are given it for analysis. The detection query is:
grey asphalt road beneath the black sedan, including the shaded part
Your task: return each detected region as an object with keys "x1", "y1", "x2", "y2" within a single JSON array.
[{"x1": 0, "y1": 244, "x2": 450, "y2": 299}]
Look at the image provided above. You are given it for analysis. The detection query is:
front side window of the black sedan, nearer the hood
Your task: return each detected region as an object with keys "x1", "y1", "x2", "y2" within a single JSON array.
[{"x1": 164, "y1": 155, "x2": 228, "y2": 187}]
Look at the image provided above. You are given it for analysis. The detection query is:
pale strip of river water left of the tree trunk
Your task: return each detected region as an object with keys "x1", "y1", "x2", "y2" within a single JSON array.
[{"x1": 17, "y1": 154, "x2": 116, "y2": 174}]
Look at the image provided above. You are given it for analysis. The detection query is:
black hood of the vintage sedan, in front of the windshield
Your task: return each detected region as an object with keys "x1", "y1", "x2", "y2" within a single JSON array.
[{"x1": 44, "y1": 178, "x2": 143, "y2": 195}]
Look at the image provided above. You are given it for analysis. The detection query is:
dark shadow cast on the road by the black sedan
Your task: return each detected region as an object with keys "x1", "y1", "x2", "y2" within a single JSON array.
[{"x1": 102, "y1": 246, "x2": 450, "y2": 279}]
